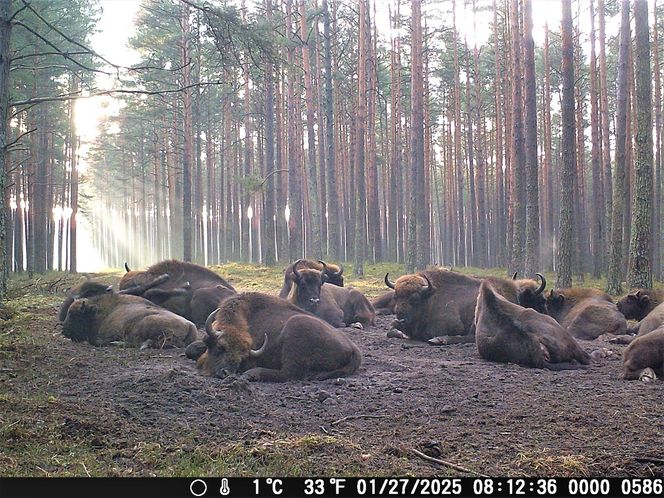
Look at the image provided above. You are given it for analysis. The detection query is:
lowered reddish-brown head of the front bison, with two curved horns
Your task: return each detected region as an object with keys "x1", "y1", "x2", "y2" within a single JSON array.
[{"x1": 197, "y1": 308, "x2": 267, "y2": 377}]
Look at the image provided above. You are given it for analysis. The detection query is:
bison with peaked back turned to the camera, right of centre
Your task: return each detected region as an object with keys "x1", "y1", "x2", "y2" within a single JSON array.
[{"x1": 475, "y1": 281, "x2": 590, "y2": 370}]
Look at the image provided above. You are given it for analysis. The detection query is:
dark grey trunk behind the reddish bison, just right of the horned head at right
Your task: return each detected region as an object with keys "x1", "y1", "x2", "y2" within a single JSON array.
[{"x1": 556, "y1": 0, "x2": 576, "y2": 288}]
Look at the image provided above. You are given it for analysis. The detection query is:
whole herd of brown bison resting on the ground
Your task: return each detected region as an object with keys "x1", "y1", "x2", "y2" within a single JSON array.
[{"x1": 58, "y1": 260, "x2": 664, "y2": 382}]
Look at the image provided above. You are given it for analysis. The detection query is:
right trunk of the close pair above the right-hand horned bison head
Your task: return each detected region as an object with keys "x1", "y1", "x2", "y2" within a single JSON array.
[{"x1": 523, "y1": 0, "x2": 541, "y2": 277}]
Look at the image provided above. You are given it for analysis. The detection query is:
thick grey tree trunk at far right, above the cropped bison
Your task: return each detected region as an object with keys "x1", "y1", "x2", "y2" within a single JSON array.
[{"x1": 628, "y1": 0, "x2": 653, "y2": 289}]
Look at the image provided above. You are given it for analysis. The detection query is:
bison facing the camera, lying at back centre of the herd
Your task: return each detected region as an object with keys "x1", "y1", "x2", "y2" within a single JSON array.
[{"x1": 288, "y1": 262, "x2": 376, "y2": 327}]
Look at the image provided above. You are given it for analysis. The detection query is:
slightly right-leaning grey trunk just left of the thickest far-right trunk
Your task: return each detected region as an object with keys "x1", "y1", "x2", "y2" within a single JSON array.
[{"x1": 600, "y1": 0, "x2": 630, "y2": 294}]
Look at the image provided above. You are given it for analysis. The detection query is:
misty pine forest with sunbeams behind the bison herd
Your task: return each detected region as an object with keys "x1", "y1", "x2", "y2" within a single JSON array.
[{"x1": 0, "y1": 0, "x2": 662, "y2": 300}]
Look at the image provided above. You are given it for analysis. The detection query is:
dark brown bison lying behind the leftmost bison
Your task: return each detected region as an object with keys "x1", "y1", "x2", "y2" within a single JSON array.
[{"x1": 119, "y1": 259, "x2": 235, "y2": 327}]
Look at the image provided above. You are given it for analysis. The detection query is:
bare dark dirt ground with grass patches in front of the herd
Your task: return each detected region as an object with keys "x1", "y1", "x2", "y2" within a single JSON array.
[{"x1": 0, "y1": 274, "x2": 664, "y2": 477}]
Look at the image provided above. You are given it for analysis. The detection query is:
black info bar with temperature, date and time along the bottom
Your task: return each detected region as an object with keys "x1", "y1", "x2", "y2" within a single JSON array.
[{"x1": 0, "y1": 477, "x2": 664, "y2": 498}]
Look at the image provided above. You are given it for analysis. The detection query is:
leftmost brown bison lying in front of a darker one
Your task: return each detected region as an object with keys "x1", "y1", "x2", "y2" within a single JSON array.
[{"x1": 62, "y1": 289, "x2": 197, "y2": 348}]
